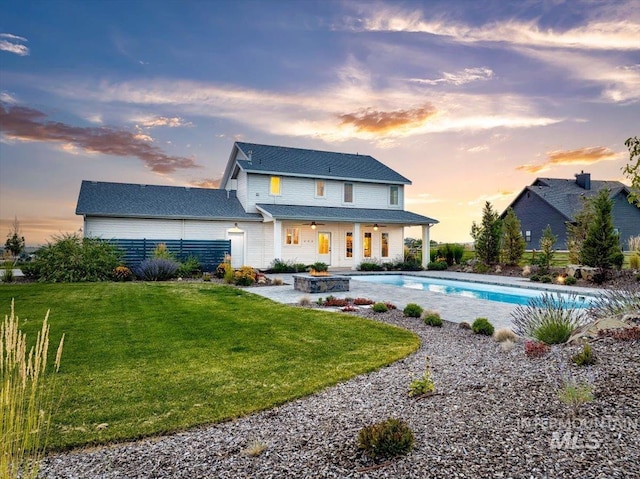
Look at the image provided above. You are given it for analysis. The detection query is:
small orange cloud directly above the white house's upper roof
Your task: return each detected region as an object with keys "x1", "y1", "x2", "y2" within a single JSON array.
[{"x1": 338, "y1": 103, "x2": 436, "y2": 133}]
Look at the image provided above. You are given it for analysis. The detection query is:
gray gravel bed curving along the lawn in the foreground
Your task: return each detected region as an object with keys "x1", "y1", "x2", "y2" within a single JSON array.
[{"x1": 41, "y1": 310, "x2": 640, "y2": 479}]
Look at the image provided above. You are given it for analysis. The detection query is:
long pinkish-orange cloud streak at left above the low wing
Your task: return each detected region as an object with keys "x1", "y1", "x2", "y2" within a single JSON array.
[{"x1": 0, "y1": 105, "x2": 200, "y2": 174}]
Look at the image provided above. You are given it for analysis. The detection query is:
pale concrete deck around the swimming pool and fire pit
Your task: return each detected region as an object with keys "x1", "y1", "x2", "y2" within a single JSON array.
[{"x1": 247, "y1": 270, "x2": 602, "y2": 328}]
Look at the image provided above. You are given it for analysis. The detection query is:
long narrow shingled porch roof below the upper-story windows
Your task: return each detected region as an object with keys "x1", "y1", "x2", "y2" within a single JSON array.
[{"x1": 256, "y1": 204, "x2": 438, "y2": 225}]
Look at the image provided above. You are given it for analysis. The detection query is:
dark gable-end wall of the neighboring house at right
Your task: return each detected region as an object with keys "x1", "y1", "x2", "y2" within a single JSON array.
[{"x1": 512, "y1": 192, "x2": 567, "y2": 250}]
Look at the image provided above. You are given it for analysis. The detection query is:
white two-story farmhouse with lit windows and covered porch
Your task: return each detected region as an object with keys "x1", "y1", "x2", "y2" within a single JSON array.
[{"x1": 76, "y1": 142, "x2": 438, "y2": 269}]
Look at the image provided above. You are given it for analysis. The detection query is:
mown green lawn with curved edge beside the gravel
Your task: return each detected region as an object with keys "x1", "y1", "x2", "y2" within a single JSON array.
[{"x1": 0, "y1": 283, "x2": 419, "y2": 449}]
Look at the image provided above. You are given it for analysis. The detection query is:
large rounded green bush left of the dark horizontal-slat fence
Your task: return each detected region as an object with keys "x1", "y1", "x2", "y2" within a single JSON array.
[{"x1": 22, "y1": 234, "x2": 122, "y2": 283}]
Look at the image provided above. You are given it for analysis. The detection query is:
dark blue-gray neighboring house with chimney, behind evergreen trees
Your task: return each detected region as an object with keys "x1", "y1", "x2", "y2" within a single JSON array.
[{"x1": 501, "y1": 172, "x2": 640, "y2": 250}]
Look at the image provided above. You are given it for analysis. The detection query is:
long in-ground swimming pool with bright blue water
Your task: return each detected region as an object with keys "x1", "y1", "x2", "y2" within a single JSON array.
[{"x1": 351, "y1": 274, "x2": 593, "y2": 307}]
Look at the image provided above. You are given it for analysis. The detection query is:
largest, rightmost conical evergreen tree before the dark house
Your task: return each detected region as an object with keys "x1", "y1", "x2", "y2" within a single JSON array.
[{"x1": 581, "y1": 190, "x2": 622, "y2": 282}]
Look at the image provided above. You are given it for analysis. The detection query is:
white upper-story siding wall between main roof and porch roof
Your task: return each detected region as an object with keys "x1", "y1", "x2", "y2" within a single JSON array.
[{"x1": 238, "y1": 172, "x2": 404, "y2": 213}]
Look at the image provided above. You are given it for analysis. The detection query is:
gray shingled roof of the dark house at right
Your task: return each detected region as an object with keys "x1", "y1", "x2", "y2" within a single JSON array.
[{"x1": 525, "y1": 178, "x2": 626, "y2": 221}]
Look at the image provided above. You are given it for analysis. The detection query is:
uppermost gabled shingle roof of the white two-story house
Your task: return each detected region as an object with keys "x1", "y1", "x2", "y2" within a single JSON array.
[{"x1": 222, "y1": 142, "x2": 411, "y2": 185}]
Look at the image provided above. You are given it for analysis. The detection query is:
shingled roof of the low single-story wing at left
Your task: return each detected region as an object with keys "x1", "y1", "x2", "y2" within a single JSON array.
[{"x1": 76, "y1": 181, "x2": 262, "y2": 221}]
